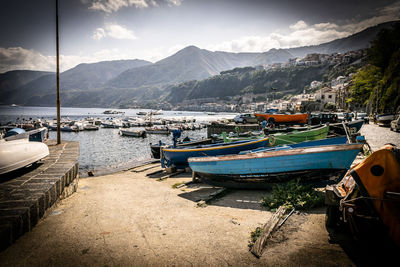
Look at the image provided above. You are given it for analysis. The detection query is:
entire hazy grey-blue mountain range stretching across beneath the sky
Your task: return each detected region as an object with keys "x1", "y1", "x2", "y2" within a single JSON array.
[{"x1": 0, "y1": 22, "x2": 393, "y2": 107}]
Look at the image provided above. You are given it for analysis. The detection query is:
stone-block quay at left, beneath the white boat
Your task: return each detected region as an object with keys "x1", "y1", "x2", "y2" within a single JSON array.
[{"x1": 0, "y1": 140, "x2": 79, "y2": 251}]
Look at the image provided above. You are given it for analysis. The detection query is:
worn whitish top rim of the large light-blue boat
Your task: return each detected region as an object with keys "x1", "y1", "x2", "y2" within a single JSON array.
[{"x1": 188, "y1": 144, "x2": 364, "y2": 163}]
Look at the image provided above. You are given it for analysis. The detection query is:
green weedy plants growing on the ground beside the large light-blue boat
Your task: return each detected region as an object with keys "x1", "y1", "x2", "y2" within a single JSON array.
[{"x1": 261, "y1": 179, "x2": 325, "y2": 210}]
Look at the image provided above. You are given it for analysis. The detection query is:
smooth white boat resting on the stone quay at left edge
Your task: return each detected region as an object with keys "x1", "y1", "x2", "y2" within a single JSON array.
[{"x1": 0, "y1": 138, "x2": 49, "y2": 174}]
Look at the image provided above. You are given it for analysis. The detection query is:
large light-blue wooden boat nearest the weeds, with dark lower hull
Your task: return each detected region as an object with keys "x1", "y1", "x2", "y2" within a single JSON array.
[{"x1": 188, "y1": 139, "x2": 363, "y2": 189}]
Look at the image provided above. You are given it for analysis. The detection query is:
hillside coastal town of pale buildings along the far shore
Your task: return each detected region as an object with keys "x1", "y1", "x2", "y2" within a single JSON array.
[{"x1": 142, "y1": 49, "x2": 371, "y2": 112}]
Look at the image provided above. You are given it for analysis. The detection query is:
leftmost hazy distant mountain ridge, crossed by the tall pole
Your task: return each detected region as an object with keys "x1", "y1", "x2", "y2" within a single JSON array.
[{"x1": 0, "y1": 59, "x2": 152, "y2": 106}]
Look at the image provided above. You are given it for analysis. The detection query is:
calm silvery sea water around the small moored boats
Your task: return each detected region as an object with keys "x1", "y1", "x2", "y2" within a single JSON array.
[{"x1": 0, "y1": 106, "x2": 234, "y2": 176}]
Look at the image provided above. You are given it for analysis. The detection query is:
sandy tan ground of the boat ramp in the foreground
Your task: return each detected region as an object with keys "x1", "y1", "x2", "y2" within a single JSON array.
[{"x1": 0, "y1": 125, "x2": 400, "y2": 266}]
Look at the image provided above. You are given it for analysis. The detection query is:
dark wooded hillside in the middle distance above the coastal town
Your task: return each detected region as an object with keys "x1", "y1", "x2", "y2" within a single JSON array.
[{"x1": 165, "y1": 65, "x2": 329, "y2": 103}]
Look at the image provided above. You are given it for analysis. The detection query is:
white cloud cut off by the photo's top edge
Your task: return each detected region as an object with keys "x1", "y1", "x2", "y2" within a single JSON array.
[{"x1": 87, "y1": 0, "x2": 182, "y2": 13}]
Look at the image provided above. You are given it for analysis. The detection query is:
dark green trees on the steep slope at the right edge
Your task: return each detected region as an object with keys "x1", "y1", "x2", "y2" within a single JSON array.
[{"x1": 348, "y1": 22, "x2": 400, "y2": 113}]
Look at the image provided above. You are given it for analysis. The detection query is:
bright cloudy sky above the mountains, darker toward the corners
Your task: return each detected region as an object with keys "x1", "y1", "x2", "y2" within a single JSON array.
[{"x1": 0, "y1": 0, "x2": 400, "y2": 73}]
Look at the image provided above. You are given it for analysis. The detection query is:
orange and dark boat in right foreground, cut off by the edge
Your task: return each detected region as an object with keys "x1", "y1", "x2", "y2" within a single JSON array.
[{"x1": 326, "y1": 144, "x2": 400, "y2": 245}]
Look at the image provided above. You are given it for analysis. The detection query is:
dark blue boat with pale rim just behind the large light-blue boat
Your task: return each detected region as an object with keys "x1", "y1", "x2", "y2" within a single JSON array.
[{"x1": 161, "y1": 137, "x2": 268, "y2": 168}]
